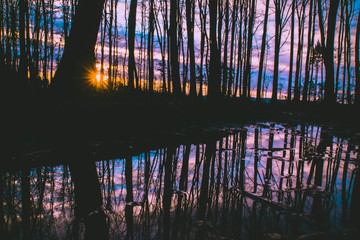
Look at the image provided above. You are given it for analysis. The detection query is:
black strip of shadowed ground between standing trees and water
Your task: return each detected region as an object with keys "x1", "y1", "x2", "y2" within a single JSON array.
[{"x1": 3, "y1": 92, "x2": 360, "y2": 169}]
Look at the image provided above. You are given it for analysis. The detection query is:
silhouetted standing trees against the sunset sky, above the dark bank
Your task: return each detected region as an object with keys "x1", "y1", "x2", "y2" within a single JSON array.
[{"x1": 0, "y1": 0, "x2": 360, "y2": 104}]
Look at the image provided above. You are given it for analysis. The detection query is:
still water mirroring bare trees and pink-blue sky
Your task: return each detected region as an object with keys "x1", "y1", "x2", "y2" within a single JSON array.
[{"x1": 0, "y1": 123, "x2": 360, "y2": 239}]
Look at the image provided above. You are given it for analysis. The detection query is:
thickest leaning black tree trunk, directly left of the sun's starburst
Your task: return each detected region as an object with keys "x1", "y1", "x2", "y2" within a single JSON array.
[{"x1": 54, "y1": 0, "x2": 105, "y2": 95}]
